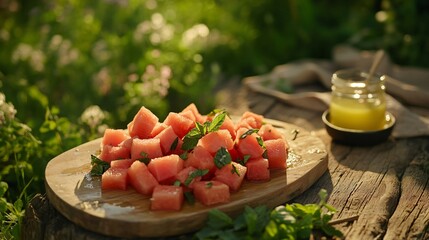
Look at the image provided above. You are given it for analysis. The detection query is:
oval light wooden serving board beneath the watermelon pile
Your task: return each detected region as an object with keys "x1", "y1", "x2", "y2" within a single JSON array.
[{"x1": 45, "y1": 119, "x2": 328, "y2": 237}]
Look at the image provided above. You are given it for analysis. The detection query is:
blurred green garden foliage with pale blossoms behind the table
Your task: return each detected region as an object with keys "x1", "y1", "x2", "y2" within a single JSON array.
[{"x1": 0, "y1": 0, "x2": 429, "y2": 238}]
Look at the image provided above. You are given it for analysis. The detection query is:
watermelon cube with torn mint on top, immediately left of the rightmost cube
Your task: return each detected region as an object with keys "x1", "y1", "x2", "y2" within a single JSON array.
[{"x1": 237, "y1": 128, "x2": 265, "y2": 158}]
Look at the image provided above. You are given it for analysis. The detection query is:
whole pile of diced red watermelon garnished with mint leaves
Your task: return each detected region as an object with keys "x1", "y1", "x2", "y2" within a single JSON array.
[{"x1": 98, "y1": 104, "x2": 289, "y2": 211}]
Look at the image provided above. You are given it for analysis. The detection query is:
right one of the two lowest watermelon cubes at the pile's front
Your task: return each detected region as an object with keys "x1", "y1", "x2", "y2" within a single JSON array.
[{"x1": 193, "y1": 181, "x2": 230, "y2": 206}]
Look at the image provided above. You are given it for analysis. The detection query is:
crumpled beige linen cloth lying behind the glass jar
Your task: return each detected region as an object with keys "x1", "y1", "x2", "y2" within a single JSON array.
[{"x1": 243, "y1": 45, "x2": 429, "y2": 138}]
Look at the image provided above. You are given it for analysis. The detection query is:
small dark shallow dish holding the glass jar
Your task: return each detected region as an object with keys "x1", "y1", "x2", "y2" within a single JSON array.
[{"x1": 322, "y1": 110, "x2": 396, "y2": 146}]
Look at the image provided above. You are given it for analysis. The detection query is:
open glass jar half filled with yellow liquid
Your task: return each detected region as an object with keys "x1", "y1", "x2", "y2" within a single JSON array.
[{"x1": 329, "y1": 69, "x2": 386, "y2": 130}]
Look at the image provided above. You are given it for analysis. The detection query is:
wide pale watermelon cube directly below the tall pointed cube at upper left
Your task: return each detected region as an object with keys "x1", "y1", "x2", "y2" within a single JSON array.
[{"x1": 131, "y1": 138, "x2": 163, "y2": 160}]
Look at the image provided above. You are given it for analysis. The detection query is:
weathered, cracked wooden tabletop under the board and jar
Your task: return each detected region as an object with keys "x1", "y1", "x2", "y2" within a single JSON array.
[{"x1": 23, "y1": 79, "x2": 429, "y2": 239}]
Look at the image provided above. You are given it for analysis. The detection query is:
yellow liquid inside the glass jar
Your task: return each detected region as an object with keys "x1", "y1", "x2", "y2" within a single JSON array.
[{"x1": 329, "y1": 99, "x2": 386, "y2": 130}]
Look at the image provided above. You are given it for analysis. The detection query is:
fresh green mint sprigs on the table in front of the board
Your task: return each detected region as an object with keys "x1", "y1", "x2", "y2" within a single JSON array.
[{"x1": 195, "y1": 189, "x2": 343, "y2": 240}]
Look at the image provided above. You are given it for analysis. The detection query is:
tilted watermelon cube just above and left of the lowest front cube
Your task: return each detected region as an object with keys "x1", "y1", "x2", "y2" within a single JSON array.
[{"x1": 128, "y1": 161, "x2": 158, "y2": 195}]
